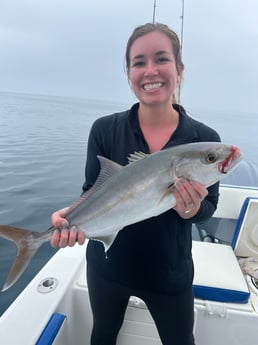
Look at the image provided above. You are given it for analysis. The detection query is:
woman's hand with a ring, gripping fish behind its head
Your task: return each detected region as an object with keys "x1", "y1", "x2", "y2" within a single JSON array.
[{"x1": 174, "y1": 178, "x2": 208, "y2": 219}]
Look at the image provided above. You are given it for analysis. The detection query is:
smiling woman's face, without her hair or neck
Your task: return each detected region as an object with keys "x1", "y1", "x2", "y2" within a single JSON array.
[{"x1": 128, "y1": 31, "x2": 180, "y2": 105}]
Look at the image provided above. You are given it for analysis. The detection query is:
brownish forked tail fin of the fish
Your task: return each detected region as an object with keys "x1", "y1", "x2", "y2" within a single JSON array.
[{"x1": 0, "y1": 225, "x2": 50, "y2": 291}]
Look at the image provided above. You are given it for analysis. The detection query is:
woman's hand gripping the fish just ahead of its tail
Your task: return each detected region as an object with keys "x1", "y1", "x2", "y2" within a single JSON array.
[{"x1": 50, "y1": 207, "x2": 85, "y2": 248}]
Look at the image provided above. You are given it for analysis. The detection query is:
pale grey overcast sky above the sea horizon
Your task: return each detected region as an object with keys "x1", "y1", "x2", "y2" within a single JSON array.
[{"x1": 0, "y1": 0, "x2": 258, "y2": 113}]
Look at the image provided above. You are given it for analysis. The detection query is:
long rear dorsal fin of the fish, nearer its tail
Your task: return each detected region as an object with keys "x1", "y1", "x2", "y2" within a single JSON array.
[{"x1": 67, "y1": 156, "x2": 123, "y2": 214}]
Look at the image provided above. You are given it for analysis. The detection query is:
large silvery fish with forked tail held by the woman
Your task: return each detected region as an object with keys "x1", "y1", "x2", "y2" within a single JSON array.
[{"x1": 0, "y1": 142, "x2": 242, "y2": 291}]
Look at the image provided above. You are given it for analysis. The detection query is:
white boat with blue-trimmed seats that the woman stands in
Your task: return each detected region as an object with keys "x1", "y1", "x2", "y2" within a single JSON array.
[{"x1": 0, "y1": 181, "x2": 258, "y2": 345}]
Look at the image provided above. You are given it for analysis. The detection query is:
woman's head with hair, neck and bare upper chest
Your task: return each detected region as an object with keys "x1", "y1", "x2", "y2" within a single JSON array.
[{"x1": 126, "y1": 23, "x2": 184, "y2": 152}]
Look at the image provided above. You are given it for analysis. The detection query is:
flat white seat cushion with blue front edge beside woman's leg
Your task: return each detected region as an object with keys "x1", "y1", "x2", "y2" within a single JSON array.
[{"x1": 192, "y1": 241, "x2": 250, "y2": 303}]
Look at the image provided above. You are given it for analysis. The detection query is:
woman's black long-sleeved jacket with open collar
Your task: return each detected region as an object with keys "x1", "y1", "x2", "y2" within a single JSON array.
[{"x1": 83, "y1": 104, "x2": 220, "y2": 294}]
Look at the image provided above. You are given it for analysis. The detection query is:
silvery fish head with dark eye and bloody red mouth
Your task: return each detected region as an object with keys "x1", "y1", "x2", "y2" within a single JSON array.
[{"x1": 172, "y1": 142, "x2": 243, "y2": 187}]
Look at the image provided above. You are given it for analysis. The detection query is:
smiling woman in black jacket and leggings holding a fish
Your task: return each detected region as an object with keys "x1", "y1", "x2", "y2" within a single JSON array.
[{"x1": 52, "y1": 23, "x2": 220, "y2": 345}]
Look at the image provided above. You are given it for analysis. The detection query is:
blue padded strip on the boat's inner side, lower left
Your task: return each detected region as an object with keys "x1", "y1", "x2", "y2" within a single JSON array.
[{"x1": 35, "y1": 313, "x2": 66, "y2": 345}]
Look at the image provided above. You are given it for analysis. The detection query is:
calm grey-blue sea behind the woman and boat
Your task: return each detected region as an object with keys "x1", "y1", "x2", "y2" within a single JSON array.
[{"x1": 0, "y1": 93, "x2": 258, "y2": 315}]
